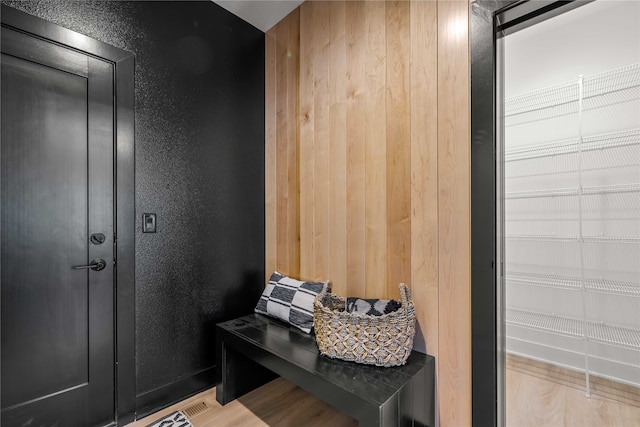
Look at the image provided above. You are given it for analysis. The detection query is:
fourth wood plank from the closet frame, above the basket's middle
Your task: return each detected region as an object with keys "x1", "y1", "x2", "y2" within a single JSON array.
[{"x1": 364, "y1": 1, "x2": 388, "y2": 298}]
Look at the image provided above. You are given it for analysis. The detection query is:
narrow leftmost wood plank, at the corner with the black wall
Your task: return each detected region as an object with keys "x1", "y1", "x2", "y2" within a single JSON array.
[{"x1": 264, "y1": 30, "x2": 278, "y2": 283}]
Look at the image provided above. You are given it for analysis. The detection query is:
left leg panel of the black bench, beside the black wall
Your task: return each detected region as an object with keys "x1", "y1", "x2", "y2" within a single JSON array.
[{"x1": 216, "y1": 341, "x2": 278, "y2": 405}]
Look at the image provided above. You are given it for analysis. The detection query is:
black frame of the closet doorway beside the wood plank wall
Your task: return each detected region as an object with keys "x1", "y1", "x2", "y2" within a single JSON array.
[{"x1": 470, "y1": 0, "x2": 593, "y2": 426}]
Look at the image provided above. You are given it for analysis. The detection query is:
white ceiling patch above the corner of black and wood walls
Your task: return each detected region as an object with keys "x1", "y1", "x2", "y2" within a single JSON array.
[{"x1": 213, "y1": 0, "x2": 304, "y2": 32}]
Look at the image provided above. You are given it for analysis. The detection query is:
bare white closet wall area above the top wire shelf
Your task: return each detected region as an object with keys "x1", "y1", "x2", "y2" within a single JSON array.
[{"x1": 504, "y1": 0, "x2": 640, "y2": 97}]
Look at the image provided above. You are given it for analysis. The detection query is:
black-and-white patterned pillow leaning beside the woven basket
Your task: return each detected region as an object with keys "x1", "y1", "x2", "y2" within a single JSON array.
[{"x1": 255, "y1": 271, "x2": 329, "y2": 333}]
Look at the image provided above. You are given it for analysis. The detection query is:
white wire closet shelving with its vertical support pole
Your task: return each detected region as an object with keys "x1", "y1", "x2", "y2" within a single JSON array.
[{"x1": 502, "y1": 64, "x2": 640, "y2": 395}]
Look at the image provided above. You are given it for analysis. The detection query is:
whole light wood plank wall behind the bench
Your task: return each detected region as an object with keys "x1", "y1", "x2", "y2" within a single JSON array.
[{"x1": 265, "y1": 0, "x2": 471, "y2": 426}]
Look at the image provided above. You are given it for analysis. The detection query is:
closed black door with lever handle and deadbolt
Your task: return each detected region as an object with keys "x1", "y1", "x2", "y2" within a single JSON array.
[{"x1": 0, "y1": 28, "x2": 115, "y2": 427}]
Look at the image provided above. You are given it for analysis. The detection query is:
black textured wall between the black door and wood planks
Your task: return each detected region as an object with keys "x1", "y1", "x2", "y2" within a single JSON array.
[{"x1": 2, "y1": 0, "x2": 264, "y2": 412}]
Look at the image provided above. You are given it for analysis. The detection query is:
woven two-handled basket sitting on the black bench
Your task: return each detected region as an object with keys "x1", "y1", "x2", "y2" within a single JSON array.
[{"x1": 313, "y1": 283, "x2": 416, "y2": 367}]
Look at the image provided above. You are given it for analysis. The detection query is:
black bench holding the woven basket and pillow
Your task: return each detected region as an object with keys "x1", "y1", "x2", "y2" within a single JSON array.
[{"x1": 216, "y1": 314, "x2": 435, "y2": 427}]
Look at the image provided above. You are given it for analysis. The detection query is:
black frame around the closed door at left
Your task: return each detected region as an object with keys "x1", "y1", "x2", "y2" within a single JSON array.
[{"x1": 2, "y1": 5, "x2": 136, "y2": 425}]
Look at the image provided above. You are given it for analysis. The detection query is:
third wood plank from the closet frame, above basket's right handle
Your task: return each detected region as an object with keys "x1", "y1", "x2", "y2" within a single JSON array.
[{"x1": 386, "y1": 1, "x2": 411, "y2": 298}]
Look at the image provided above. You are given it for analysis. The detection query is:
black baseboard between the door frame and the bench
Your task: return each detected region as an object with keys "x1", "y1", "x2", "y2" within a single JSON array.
[{"x1": 136, "y1": 365, "x2": 216, "y2": 420}]
